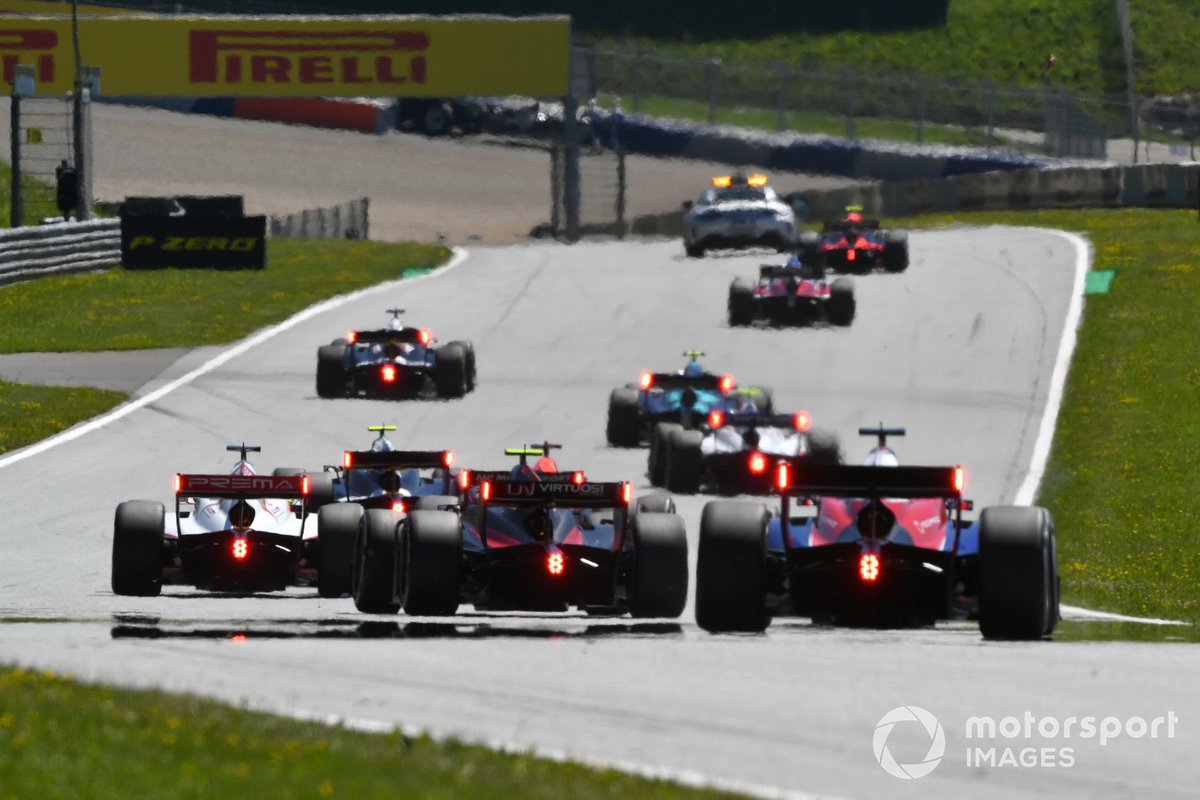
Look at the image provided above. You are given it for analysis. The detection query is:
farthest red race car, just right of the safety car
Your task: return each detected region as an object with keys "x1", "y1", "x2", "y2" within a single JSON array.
[{"x1": 799, "y1": 205, "x2": 908, "y2": 272}]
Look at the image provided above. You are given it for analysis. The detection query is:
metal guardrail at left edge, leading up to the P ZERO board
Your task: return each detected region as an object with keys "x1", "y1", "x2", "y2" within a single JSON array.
[{"x1": 0, "y1": 219, "x2": 121, "y2": 283}]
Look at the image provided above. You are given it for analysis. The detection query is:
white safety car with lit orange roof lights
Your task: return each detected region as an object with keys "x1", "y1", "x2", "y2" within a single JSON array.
[{"x1": 683, "y1": 173, "x2": 796, "y2": 258}]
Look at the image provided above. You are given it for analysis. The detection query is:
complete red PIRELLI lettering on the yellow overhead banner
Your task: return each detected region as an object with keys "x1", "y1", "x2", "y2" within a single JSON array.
[{"x1": 188, "y1": 30, "x2": 430, "y2": 84}]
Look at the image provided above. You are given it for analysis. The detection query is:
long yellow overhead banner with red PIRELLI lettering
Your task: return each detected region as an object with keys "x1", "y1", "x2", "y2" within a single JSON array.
[{"x1": 0, "y1": 14, "x2": 570, "y2": 97}]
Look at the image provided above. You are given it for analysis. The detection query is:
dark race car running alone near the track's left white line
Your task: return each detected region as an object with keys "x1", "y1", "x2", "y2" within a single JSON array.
[{"x1": 317, "y1": 308, "x2": 475, "y2": 398}]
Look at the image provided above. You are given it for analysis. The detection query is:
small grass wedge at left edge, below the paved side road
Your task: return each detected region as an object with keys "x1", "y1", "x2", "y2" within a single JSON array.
[{"x1": 0, "y1": 381, "x2": 127, "y2": 453}]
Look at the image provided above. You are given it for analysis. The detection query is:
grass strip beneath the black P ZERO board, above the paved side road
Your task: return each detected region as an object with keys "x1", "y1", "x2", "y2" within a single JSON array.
[{"x1": 0, "y1": 239, "x2": 449, "y2": 353}]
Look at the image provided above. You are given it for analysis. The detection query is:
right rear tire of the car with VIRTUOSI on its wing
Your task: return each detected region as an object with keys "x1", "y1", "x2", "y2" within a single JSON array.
[{"x1": 629, "y1": 513, "x2": 688, "y2": 619}]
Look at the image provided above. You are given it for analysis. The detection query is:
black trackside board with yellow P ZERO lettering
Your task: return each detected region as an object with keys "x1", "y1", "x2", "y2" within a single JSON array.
[{"x1": 121, "y1": 215, "x2": 266, "y2": 270}]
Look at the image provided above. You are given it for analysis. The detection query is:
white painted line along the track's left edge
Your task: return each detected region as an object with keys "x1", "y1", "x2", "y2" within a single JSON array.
[{"x1": 0, "y1": 247, "x2": 469, "y2": 469}]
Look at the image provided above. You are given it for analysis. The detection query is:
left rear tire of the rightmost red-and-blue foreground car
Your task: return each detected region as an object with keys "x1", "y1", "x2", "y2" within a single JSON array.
[{"x1": 696, "y1": 500, "x2": 770, "y2": 633}]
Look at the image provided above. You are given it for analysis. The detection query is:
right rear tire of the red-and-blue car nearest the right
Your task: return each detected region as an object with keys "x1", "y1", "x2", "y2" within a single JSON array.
[{"x1": 979, "y1": 506, "x2": 1058, "y2": 639}]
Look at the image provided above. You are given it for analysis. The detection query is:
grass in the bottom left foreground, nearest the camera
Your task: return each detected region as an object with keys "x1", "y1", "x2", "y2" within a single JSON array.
[{"x1": 0, "y1": 669, "x2": 733, "y2": 800}]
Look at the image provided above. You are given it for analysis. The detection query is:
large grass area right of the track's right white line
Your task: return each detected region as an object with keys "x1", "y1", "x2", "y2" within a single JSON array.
[{"x1": 906, "y1": 209, "x2": 1200, "y2": 624}]
